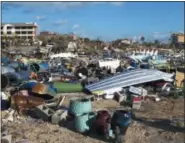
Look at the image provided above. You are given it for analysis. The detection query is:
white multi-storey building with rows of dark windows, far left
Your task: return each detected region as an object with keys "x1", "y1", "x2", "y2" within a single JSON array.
[{"x1": 1, "y1": 23, "x2": 38, "y2": 41}]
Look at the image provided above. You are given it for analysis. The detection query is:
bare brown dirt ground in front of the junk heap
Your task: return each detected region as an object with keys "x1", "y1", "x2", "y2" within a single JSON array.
[{"x1": 1, "y1": 95, "x2": 185, "y2": 143}]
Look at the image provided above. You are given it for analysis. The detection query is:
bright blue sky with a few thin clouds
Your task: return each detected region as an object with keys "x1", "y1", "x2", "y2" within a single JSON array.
[{"x1": 1, "y1": 2, "x2": 184, "y2": 41}]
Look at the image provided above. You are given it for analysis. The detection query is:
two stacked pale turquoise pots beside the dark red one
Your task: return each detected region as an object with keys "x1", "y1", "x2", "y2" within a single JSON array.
[{"x1": 69, "y1": 98, "x2": 96, "y2": 133}]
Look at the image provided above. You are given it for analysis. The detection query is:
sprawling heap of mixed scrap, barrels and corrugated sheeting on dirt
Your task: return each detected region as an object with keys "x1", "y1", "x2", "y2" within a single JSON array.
[{"x1": 1, "y1": 49, "x2": 184, "y2": 142}]
